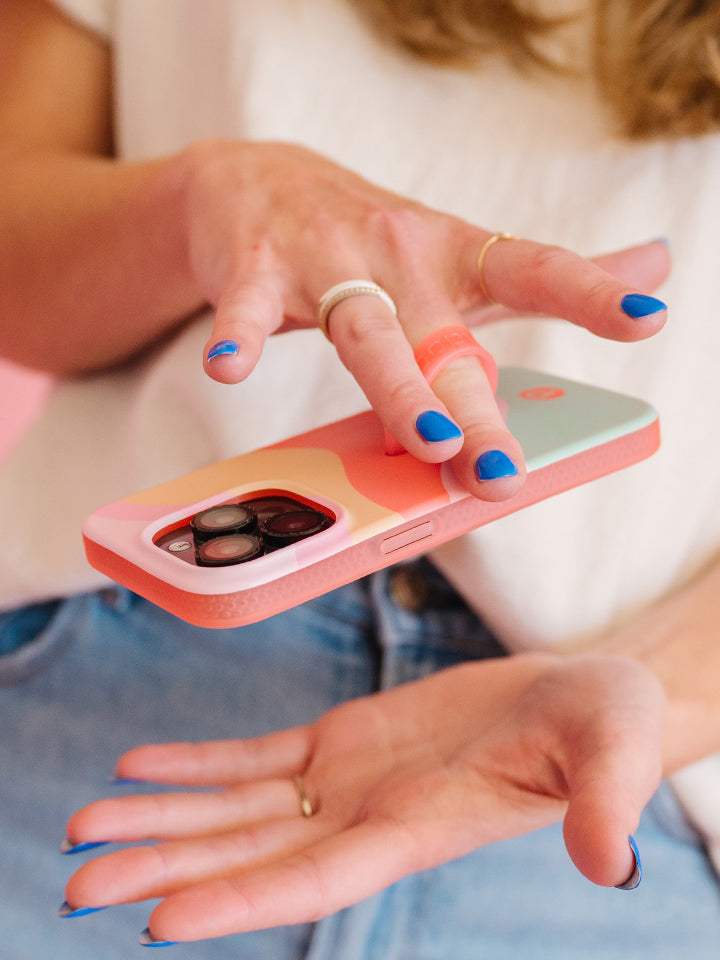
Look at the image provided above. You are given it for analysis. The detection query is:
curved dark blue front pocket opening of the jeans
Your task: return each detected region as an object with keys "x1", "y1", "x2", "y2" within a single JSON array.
[{"x1": 0, "y1": 600, "x2": 72, "y2": 687}]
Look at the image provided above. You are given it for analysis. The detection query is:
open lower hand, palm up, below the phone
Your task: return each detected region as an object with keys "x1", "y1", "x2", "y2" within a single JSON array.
[{"x1": 60, "y1": 654, "x2": 665, "y2": 942}]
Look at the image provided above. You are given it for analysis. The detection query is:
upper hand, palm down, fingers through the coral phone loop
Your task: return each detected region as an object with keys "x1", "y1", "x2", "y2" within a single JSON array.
[{"x1": 182, "y1": 141, "x2": 669, "y2": 500}]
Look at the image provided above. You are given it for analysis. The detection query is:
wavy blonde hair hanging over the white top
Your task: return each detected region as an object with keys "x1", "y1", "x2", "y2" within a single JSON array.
[{"x1": 352, "y1": 0, "x2": 720, "y2": 138}]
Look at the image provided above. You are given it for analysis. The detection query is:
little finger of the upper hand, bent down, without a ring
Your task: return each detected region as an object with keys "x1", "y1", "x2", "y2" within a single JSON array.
[{"x1": 203, "y1": 279, "x2": 283, "y2": 383}]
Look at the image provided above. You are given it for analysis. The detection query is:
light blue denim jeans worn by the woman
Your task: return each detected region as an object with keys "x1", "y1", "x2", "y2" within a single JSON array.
[{"x1": 0, "y1": 561, "x2": 720, "y2": 960}]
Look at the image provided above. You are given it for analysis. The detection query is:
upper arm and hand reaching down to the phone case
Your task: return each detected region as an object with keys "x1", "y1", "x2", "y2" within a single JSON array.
[{"x1": 0, "y1": 0, "x2": 669, "y2": 500}]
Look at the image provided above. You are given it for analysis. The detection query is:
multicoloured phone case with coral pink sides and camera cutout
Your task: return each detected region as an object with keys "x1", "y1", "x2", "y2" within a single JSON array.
[{"x1": 83, "y1": 368, "x2": 660, "y2": 627}]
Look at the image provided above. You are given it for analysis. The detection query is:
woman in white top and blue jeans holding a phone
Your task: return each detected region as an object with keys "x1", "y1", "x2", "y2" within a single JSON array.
[{"x1": 0, "y1": 0, "x2": 720, "y2": 957}]
